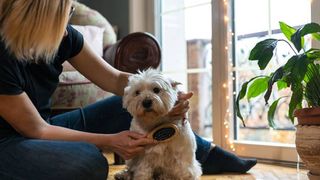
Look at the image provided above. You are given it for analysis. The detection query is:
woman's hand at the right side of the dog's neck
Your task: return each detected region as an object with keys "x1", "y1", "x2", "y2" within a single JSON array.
[{"x1": 167, "y1": 92, "x2": 193, "y2": 121}]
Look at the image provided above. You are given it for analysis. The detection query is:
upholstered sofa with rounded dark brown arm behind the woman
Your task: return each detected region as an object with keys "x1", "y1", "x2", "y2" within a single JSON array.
[{"x1": 52, "y1": 2, "x2": 161, "y2": 115}]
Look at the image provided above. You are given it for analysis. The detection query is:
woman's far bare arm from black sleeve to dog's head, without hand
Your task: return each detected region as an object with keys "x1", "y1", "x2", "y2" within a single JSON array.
[{"x1": 69, "y1": 41, "x2": 130, "y2": 96}]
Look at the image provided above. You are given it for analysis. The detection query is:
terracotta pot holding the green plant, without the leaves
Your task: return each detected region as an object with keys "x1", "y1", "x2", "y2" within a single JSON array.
[{"x1": 294, "y1": 108, "x2": 320, "y2": 180}]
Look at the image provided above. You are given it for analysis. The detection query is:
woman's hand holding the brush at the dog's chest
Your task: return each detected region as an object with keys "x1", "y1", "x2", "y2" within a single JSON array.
[{"x1": 110, "y1": 131, "x2": 157, "y2": 160}]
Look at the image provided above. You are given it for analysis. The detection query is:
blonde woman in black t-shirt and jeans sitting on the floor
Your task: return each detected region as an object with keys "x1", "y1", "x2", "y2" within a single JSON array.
[{"x1": 0, "y1": 0, "x2": 256, "y2": 180}]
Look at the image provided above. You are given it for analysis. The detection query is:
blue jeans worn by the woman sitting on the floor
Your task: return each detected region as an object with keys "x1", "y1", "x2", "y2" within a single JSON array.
[{"x1": 0, "y1": 96, "x2": 210, "y2": 180}]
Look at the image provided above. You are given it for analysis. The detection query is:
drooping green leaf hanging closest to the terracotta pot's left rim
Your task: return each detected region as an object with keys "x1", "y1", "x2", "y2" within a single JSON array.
[{"x1": 288, "y1": 84, "x2": 303, "y2": 123}]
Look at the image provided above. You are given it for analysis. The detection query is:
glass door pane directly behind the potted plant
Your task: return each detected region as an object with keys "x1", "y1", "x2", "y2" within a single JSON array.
[{"x1": 232, "y1": 0, "x2": 313, "y2": 161}]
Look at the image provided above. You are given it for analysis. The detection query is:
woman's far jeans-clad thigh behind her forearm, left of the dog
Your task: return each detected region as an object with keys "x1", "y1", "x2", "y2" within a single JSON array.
[{"x1": 50, "y1": 96, "x2": 132, "y2": 134}]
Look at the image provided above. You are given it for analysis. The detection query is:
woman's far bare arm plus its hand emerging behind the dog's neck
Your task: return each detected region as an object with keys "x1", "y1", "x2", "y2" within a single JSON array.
[{"x1": 69, "y1": 42, "x2": 193, "y2": 119}]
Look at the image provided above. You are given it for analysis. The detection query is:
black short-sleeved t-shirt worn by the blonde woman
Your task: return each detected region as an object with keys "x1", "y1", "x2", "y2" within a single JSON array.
[{"x1": 0, "y1": 25, "x2": 83, "y2": 138}]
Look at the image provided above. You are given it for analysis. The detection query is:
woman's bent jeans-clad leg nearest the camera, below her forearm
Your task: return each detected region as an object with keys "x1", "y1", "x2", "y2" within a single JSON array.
[{"x1": 0, "y1": 136, "x2": 108, "y2": 180}]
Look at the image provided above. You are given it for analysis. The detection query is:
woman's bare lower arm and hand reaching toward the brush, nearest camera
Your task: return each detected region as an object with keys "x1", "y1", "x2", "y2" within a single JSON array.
[{"x1": 0, "y1": 93, "x2": 155, "y2": 159}]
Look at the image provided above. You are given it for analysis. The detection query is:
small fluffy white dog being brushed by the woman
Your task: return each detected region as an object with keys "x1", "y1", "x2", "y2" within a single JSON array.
[{"x1": 116, "y1": 69, "x2": 202, "y2": 180}]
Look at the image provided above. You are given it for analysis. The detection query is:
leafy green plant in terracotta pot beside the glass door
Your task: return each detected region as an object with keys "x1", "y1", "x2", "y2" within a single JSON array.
[{"x1": 236, "y1": 22, "x2": 320, "y2": 179}]
